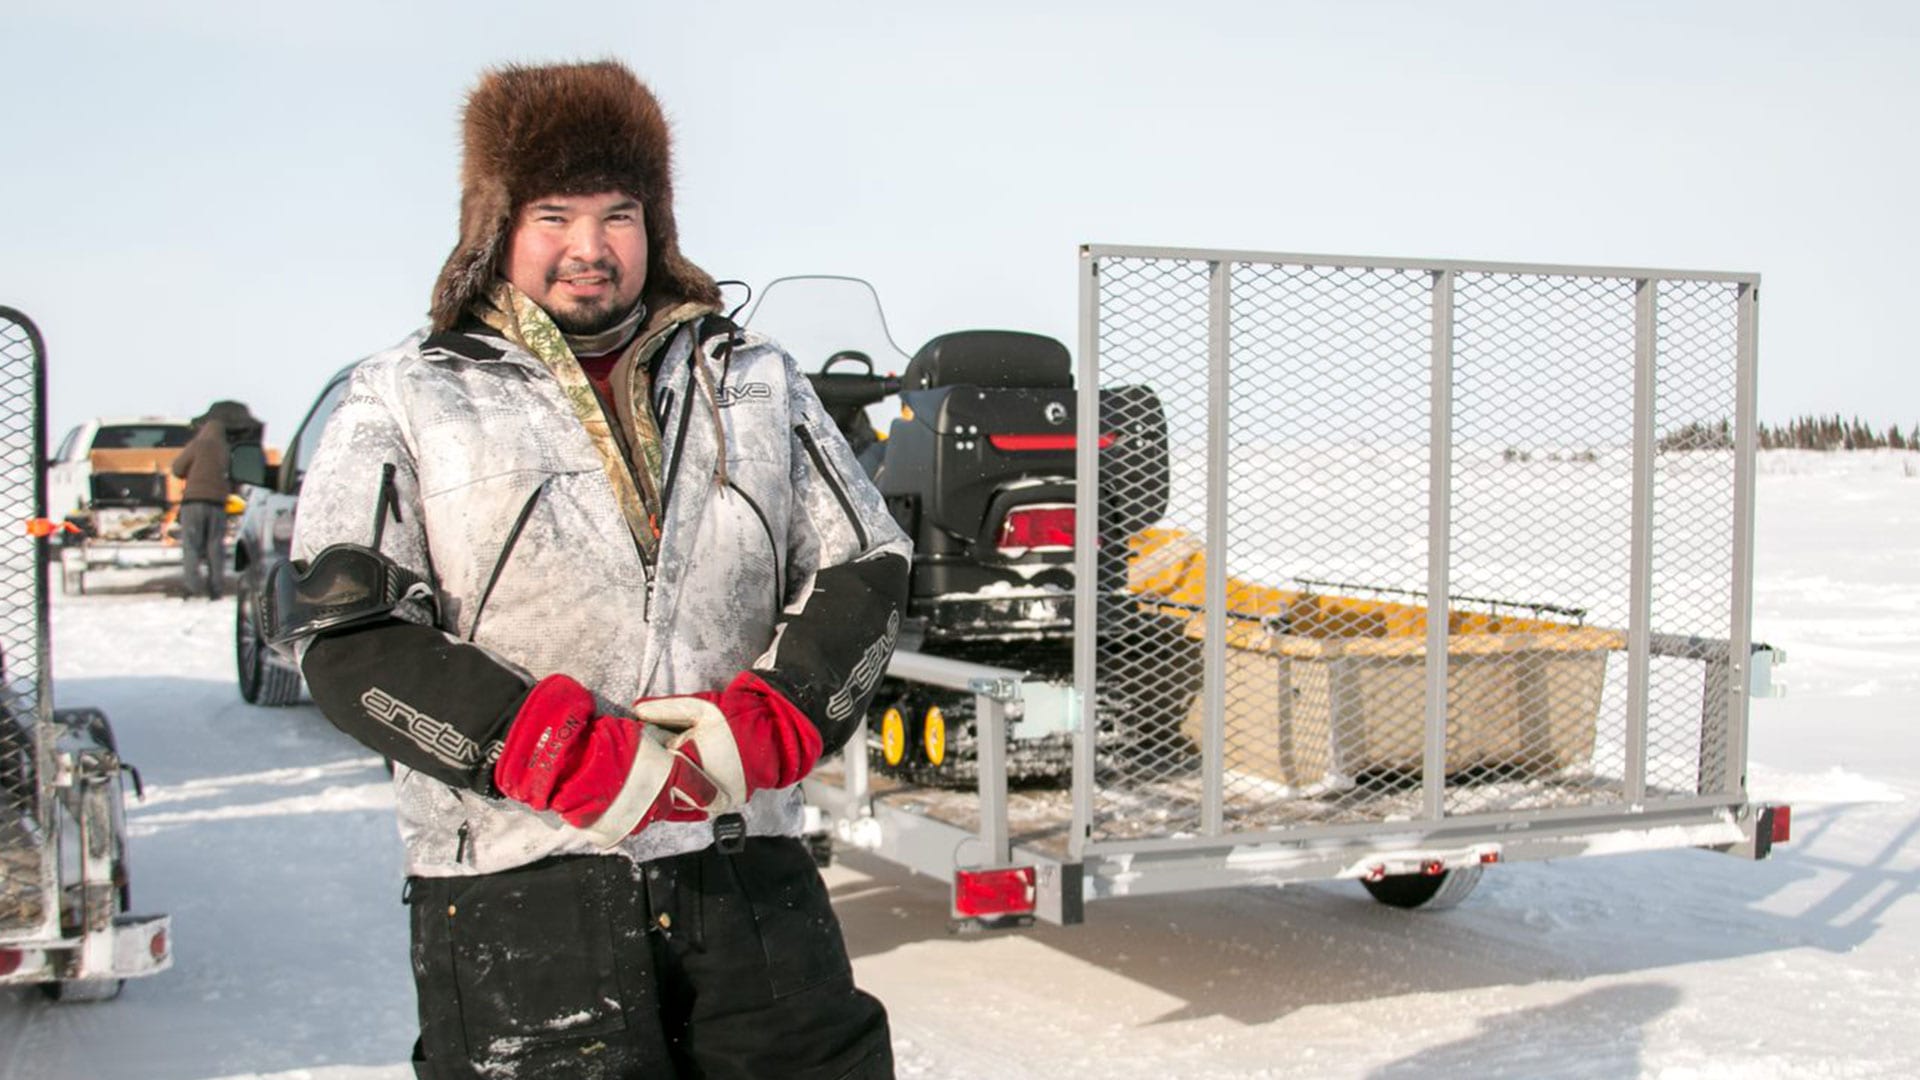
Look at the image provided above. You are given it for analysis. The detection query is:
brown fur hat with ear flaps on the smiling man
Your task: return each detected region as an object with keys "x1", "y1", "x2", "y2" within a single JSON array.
[{"x1": 432, "y1": 60, "x2": 720, "y2": 331}]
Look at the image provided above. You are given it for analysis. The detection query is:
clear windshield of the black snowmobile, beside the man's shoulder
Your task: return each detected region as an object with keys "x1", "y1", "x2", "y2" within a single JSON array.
[{"x1": 747, "y1": 275, "x2": 910, "y2": 375}]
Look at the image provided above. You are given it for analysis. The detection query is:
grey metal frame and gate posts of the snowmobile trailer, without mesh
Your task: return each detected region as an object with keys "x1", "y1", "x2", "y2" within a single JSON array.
[{"x1": 806, "y1": 244, "x2": 1789, "y2": 924}]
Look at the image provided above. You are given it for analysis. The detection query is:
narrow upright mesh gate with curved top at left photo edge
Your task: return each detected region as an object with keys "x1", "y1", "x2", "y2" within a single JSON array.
[{"x1": 0, "y1": 307, "x2": 54, "y2": 940}]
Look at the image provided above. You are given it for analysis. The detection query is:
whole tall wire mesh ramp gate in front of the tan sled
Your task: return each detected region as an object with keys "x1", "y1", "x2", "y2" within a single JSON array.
[{"x1": 1079, "y1": 248, "x2": 1747, "y2": 846}]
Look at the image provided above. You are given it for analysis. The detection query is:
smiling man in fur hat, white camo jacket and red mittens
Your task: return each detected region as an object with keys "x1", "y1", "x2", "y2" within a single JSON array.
[{"x1": 263, "y1": 61, "x2": 908, "y2": 1080}]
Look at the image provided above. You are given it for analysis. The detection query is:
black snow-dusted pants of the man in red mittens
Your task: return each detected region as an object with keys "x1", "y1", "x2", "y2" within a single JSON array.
[{"x1": 407, "y1": 836, "x2": 893, "y2": 1080}]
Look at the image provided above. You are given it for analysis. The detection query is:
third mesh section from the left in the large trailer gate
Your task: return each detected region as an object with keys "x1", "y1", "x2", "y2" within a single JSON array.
[{"x1": 1446, "y1": 273, "x2": 1636, "y2": 813}]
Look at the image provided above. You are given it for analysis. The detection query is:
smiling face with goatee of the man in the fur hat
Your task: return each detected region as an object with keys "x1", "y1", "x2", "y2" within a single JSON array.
[{"x1": 507, "y1": 192, "x2": 647, "y2": 334}]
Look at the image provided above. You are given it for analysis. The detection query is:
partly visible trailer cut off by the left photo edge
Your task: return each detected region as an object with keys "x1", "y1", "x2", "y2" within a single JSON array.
[{"x1": 0, "y1": 307, "x2": 173, "y2": 1001}]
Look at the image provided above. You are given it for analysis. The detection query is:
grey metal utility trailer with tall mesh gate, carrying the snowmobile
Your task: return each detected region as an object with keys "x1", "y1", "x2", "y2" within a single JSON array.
[{"x1": 806, "y1": 246, "x2": 1789, "y2": 924}]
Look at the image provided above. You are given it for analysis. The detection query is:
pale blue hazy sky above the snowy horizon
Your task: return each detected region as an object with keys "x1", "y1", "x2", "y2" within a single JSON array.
[{"x1": 0, "y1": 0, "x2": 1920, "y2": 440}]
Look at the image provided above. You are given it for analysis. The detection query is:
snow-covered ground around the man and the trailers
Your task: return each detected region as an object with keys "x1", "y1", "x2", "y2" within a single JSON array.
[{"x1": 0, "y1": 454, "x2": 1920, "y2": 1080}]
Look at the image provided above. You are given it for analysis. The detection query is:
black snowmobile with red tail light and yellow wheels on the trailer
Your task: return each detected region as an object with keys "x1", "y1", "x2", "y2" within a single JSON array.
[{"x1": 747, "y1": 277, "x2": 1200, "y2": 786}]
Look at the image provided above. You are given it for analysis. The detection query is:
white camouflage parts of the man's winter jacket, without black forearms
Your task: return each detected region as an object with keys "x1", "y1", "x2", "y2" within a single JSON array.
[{"x1": 292, "y1": 311, "x2": 908, "y2": 876}]
